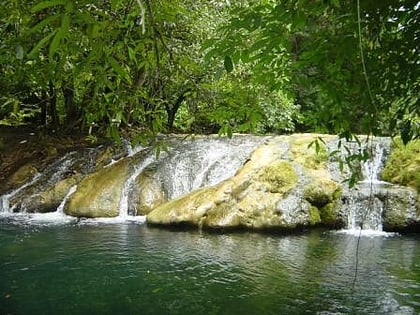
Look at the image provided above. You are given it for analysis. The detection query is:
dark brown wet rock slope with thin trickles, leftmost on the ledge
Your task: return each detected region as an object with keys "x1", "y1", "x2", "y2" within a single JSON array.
[{"x1": 0, "y1": 146, "x2": 128, "y2": 213}]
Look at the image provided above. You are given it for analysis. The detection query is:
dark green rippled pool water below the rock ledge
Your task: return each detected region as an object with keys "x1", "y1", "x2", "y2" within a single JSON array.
[{"x1": 0, "y1": 221, "x2": 420, "y2": 314}]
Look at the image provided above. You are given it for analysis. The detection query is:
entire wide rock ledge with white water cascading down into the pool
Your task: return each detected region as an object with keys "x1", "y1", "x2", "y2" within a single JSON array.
[{"x1": 0, "y1": 134, "x2": 420, "y2": 232}]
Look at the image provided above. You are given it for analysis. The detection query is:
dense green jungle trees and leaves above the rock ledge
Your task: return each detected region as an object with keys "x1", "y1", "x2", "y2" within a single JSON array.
[{"x1": 0, "y1": 0, "x2": 420, "y2": 142}]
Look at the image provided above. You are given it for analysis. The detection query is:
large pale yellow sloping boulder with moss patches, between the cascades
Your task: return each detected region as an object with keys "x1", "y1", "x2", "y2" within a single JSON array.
[{"x1": 147, "y1": 137, "x2": 342, "y2": 230}]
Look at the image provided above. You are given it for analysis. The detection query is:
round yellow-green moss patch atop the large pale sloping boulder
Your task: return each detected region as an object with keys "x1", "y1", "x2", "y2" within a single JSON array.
[{"x1": 258, "y1": 161, "x2": 298, "y2": 194}]
